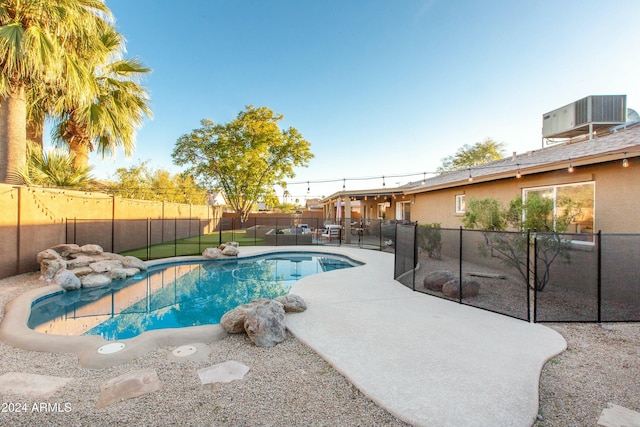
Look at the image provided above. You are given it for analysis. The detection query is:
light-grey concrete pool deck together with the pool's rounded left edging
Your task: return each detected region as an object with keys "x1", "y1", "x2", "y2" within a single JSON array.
[{"x1": 0, "y1": 246, "x2": 566, "y2": 426}]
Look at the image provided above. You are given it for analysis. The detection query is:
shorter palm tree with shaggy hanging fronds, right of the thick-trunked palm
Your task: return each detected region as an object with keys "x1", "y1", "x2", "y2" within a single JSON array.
[{"x1": 53, "y1": 27, "x2": 151, "y2": 171}]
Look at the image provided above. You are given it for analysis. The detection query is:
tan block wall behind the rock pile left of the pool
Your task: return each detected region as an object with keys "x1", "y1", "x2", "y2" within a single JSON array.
[{"x1": 0, "y1": 184, "x2": 215, "y2": 278}]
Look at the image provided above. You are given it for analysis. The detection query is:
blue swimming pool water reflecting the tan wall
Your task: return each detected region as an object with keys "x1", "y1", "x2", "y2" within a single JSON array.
[{"x1": 28, "y1": 252, "x2": 361, "y2": 340}]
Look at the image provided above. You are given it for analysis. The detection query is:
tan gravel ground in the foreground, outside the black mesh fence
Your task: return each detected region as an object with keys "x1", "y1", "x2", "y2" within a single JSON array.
[{"x1": 0, "y1": 275, "x2": 640, "y2": 427}]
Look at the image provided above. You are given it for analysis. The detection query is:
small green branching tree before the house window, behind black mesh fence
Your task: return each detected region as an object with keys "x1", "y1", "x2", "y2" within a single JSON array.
[{"x1": 462, "y1": 193, "x2": 580, "y2": 291}]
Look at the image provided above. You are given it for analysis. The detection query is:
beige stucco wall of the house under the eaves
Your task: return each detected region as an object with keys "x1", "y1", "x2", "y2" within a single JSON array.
[{"x1": 411, "y1": 161, "x2": 640, "y2": 233}]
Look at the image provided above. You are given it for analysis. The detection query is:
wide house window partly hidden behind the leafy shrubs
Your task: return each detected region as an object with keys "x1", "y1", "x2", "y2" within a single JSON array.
[{"x1": 523, "y1": 182, "x2": 595, "y2": 242}]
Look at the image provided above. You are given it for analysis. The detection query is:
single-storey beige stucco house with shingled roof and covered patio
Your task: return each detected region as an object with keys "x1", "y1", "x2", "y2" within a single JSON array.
[{"x1": 323, "y1": 123, "x2": 640, "y2": 233}]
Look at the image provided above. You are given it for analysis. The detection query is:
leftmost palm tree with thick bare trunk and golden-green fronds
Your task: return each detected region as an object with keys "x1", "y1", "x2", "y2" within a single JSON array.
[{"x1": 0, "y1": 0, "x2": 110, "y2": 182}]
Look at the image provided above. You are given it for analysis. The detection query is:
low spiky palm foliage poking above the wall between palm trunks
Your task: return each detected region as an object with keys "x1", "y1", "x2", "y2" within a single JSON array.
[{"x1": 19, "y1": 143, "x2": 93, "y2": 187}]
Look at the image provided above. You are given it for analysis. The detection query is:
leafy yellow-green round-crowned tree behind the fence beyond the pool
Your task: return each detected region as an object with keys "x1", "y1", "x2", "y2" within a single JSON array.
[{"x1": 172, "y1": 105, "x2": 313, "y2": 223}]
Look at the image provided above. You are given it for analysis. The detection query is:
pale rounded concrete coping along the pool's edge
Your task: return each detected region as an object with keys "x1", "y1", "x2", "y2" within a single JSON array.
[{"x1": 0, "y1": 246, "x2": 365, "y2": 369}]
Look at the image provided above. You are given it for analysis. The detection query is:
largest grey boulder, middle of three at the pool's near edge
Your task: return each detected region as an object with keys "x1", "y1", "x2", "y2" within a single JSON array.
[{"x1": 244, "y1": 300, "x2": 286, "y2": 347}]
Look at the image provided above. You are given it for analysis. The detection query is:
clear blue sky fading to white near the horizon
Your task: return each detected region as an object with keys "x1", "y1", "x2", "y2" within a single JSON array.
[{"x1": 48, "y1": 0, "x2": 640, "y2": 200}]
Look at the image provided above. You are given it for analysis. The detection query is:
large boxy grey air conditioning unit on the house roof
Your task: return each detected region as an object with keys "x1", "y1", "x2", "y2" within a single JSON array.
[{"x1": 542, "y1": 95, "x2": 627, "y2": 139}]
